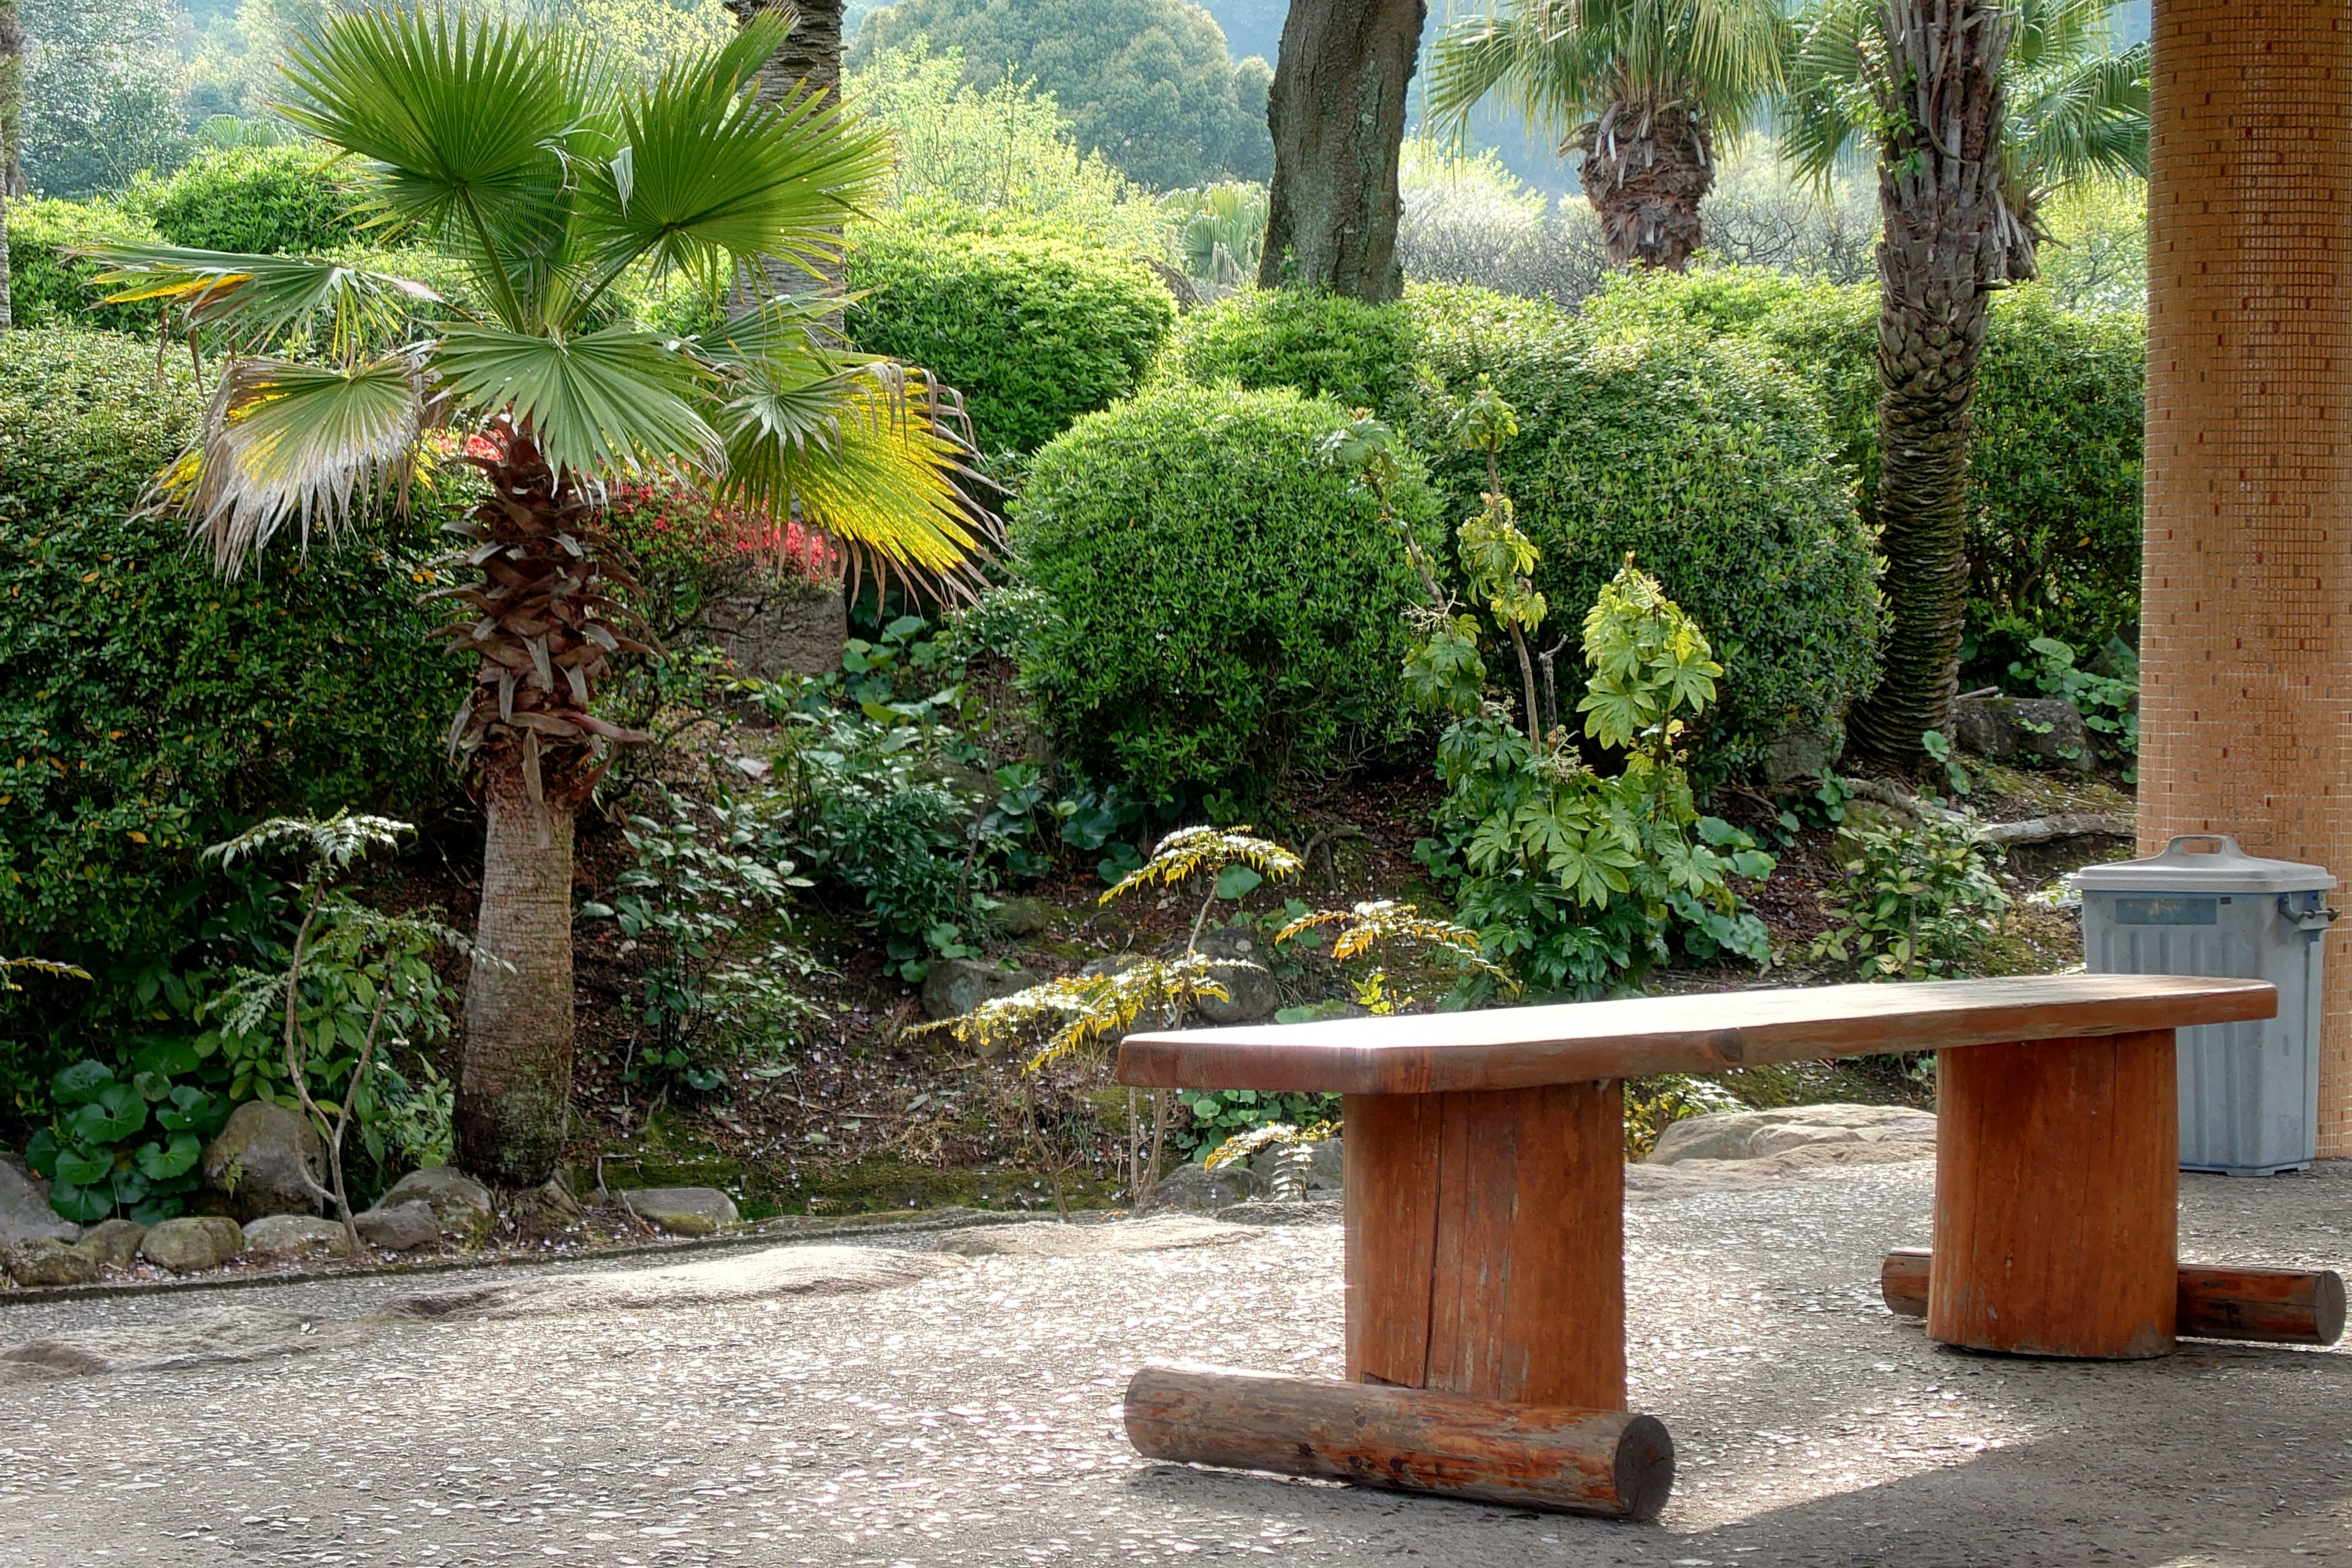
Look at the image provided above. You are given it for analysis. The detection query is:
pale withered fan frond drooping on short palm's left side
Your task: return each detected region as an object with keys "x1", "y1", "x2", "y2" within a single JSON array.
[{"x1": 157, "y1": 355, "x2": 426, "y2": 578}]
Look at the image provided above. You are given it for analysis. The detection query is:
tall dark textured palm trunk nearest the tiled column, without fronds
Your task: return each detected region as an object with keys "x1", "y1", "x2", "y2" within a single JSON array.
[{"x1": 1849, "y1": 0, "x2": 2032, "y2": 769}]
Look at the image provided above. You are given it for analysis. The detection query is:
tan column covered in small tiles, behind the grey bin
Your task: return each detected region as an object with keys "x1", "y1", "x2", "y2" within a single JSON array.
[{"x1": 2140, "y1": 0, "x2": 2352, "y2": 1154}]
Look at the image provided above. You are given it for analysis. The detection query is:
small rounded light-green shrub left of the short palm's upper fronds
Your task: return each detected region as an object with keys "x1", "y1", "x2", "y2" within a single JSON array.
[{"x1": 134, "y1": 141, "x2": 362, "y2": 256}]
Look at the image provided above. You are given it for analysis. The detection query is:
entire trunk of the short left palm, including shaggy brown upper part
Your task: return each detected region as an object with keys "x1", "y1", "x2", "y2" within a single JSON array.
[{"x1": 433, "y1": 426, "x2": 649, "y2": 1185}]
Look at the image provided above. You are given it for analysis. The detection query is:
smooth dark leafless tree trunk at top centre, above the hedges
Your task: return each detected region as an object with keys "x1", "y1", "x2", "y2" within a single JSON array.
[{"x1": 1258, "y1": 0, "x2": 1428, "y2": 303}]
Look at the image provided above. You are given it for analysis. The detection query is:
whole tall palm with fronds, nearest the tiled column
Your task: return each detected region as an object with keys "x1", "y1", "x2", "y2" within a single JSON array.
[{"x1": 1783, "y1": 0, "x2": 2150, "y2": 769}]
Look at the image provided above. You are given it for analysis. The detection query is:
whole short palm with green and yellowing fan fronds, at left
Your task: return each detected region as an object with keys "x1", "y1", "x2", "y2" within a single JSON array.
[{"x1": 96, "y1": 9, "x2": 992, "y2": 1183}]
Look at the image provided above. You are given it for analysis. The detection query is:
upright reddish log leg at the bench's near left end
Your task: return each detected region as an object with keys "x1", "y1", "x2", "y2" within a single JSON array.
[{"x1": 1348, "y1": 1082, "x2": 1625, "y2": 1411}]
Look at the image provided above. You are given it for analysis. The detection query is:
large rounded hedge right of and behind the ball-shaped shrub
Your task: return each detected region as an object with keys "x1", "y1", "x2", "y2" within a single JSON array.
[{"x1": 1171, "y1": 287, "x2": 1877, "y2": 774}]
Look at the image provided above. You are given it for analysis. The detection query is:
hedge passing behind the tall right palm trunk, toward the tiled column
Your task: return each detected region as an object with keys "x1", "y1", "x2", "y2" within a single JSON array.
[{"x1": 1585, "y1": 268, "x2": 2147, "y2": 668}]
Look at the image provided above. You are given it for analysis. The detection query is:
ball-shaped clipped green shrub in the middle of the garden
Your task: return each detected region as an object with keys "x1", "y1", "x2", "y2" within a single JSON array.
[{"x1": 1014, "y1": 385, "x2": 1437, "y2": 792}]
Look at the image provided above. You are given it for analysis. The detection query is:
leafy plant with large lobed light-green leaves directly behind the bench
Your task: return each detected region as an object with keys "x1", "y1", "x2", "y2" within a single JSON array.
[{"x1": 1324, "y1": 399, "x2": 1773, "y2": 997}]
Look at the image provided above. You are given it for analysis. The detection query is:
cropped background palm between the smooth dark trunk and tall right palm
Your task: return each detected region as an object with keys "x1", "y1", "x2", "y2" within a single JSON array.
[{"x1": 1430, "y1": 0, "x2": 1785, "y2": 273}]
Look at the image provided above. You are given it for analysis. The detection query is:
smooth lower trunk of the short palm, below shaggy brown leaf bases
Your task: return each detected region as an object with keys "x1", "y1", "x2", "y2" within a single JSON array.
[{"x1": 456, "y1": 790, "x2": 571, "y2": 1187}]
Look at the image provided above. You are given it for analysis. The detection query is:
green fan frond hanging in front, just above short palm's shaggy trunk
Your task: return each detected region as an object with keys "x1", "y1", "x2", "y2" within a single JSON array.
[{"x1": 431, "y1": 326, "x2": 725, "y2": 475}]
